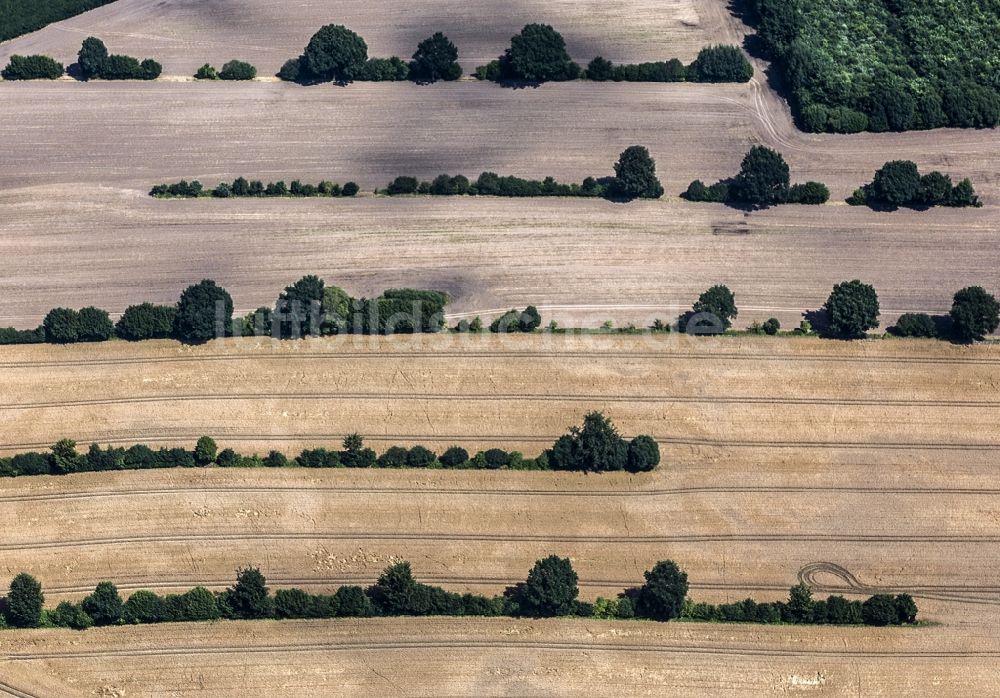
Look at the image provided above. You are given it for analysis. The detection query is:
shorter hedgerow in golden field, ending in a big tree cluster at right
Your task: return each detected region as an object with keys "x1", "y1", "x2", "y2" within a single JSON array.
[{"x1": 0, "y1": 412, "x2": 660, "y2": 477}]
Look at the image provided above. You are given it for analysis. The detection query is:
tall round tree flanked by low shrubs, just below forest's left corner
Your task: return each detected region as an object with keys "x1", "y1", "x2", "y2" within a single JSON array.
[{"x1": 681, "y1": 145, "x2": 830, "y2": 208}]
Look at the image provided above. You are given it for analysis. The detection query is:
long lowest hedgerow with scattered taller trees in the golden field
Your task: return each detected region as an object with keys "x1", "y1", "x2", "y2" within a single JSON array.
[{"x1": 0, "y1": 555, "x2": 918, "y2": 630}]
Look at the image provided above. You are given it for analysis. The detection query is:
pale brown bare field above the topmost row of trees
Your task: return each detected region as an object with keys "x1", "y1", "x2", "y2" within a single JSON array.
[{"x1": 0, "y1": 0, "x2": 735, "y2": 75}]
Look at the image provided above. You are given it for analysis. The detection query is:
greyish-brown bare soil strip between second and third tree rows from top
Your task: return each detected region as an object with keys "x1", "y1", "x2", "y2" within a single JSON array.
[{"x1": 0, "y1": 186, "x2": 1000, "y2": 328}]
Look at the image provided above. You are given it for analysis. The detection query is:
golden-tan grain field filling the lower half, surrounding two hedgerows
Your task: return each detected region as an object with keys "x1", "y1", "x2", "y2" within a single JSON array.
[{"x1": 0, "y1": 337, "x2": 1000, "y2": 695}]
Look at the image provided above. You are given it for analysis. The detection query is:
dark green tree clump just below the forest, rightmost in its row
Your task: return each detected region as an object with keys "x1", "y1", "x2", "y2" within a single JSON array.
[{"x1": 847, "y1": 160, "x2": 983, "y2": 209}]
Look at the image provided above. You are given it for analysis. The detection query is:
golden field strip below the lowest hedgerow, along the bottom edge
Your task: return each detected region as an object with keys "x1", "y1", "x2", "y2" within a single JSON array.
[{"x1": 0, "y1": 619, "x2": 1000, "y2": 698}]
